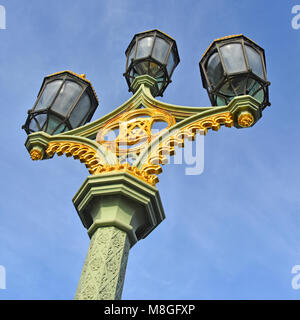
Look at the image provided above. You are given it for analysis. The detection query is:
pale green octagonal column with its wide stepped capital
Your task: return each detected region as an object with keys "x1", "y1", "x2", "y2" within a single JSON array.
[{"x1": 73, "y1": 172, "x2": 165, "y2": 300}]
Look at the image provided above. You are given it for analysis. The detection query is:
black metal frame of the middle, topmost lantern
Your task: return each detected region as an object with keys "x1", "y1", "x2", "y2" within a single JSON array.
[{"x1": 123, "y1": 29, "x2": 180, "y2": 96}]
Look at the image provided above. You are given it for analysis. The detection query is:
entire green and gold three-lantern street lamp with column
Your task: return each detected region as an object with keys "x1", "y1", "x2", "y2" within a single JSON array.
[{"x1": 23, "y1": 30, "x2": 270, "y2": 300}]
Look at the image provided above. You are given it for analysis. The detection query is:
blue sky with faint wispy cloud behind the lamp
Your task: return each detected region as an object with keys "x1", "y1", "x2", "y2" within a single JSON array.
[{"x1": 0, "y1": 0, "x2": 300, "y2": 299}]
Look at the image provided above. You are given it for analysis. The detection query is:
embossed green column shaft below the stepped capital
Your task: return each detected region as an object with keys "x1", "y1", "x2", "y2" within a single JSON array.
[{"x1": 75, "y1": 227, "x2": 130, "y2": 300}]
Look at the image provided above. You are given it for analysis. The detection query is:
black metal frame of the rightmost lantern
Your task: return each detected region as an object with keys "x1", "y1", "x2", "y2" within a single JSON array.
[{"x1": 199, "y1": 35, "x2": 270, "y2": 109}]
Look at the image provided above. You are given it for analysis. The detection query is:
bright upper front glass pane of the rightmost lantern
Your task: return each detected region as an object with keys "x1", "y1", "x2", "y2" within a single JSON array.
[{"x1": 220, "y1": 43, "x2": 247, "y2": 73}]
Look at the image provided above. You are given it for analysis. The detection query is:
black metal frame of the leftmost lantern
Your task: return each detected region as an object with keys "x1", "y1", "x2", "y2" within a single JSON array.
[{"x1": 22, "y1": 71, "x2": 99, "y2": 134}]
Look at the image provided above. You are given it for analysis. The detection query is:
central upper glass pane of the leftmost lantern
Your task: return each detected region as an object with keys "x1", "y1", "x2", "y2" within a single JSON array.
[{"x1": 51, "y1": 80, "x2": 82, "y2": 116}]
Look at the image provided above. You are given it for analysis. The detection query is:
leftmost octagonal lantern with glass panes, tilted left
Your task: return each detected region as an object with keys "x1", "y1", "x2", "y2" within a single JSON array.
[{"x1": 23, "y1": 71, "x2": 99, "y2": 135}]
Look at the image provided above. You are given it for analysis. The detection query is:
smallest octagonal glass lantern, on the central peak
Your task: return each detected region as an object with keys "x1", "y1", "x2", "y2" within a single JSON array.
[{"x1": 124, "y1": 30, "x2": 180, "y2": 96}]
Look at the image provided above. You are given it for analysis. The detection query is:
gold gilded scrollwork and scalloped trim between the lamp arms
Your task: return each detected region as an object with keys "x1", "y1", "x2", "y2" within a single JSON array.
[{"x1": 46, "y1": 109, "x2": 233, "y2": 186}]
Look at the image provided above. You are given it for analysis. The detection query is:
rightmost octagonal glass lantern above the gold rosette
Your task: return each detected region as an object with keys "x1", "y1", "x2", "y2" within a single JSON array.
[{"x1": 199, "y1": 35, "x2": 270, "y2": 109}]
